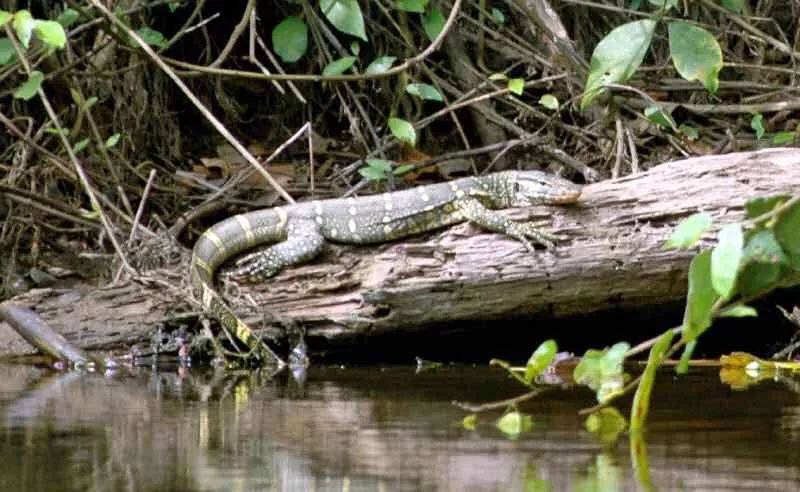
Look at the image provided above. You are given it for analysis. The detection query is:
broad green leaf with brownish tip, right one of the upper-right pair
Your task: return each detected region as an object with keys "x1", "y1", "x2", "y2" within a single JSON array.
[{"x1": 667, "y1": 21, "x2": 722, "y2": 94}]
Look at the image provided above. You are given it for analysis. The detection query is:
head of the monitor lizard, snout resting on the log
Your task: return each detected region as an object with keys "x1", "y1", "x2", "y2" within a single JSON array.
[{"x1": 505, "y1": 171, "x2": 581, "y2": 207}]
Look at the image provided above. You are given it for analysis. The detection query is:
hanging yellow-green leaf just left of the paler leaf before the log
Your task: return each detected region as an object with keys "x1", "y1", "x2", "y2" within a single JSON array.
[{"x1": 683, "y1": 251, "x2": 717, "y2": 341}]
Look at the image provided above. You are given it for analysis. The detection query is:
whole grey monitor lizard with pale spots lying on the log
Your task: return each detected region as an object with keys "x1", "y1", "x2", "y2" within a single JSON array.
[{"x1": 190, "y1": 171, "x2": 580, "y2": 366}]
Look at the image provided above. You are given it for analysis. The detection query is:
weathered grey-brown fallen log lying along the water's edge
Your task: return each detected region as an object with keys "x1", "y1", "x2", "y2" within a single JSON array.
[{"x1": 0, "y1": 149, "x2": 800, "y2": 353}]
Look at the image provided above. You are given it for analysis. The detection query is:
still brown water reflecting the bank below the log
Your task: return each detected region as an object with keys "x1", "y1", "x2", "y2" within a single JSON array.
[{"x1": 0, "y1": 365, "x2": 800, "y2": 491}]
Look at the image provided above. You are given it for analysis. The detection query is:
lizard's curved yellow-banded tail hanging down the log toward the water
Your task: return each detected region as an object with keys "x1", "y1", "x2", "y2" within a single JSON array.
[{"x1": 189, "y1": 209, "x2": 286, "y2": 367}]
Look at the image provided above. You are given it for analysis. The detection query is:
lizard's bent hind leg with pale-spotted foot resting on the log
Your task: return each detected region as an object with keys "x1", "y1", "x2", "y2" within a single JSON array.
[{"x1": 221, "y1": 220, "x2": 325, "y2": 282}]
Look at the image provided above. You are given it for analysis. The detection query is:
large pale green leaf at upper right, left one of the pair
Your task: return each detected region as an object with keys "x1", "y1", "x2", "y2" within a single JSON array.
[{"x1": 581, "y1": 19, "x2": 656, "y2": 109}]
